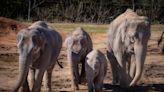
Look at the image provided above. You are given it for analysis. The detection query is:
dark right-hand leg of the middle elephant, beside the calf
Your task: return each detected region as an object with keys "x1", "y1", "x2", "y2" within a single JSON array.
[{"x1": 80, "y1": 59, "x2": 86, "y2": 84}]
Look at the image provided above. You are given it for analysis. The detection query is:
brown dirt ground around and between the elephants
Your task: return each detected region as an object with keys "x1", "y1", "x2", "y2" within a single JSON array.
[{"x1": 0, "y1": 18, "x2": 164, "y2": 92}]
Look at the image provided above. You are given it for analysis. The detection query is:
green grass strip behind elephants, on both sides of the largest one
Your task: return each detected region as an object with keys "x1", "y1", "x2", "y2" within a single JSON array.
[{"x1": 29, "y1": 22, "x2": 164, "y2": 33}]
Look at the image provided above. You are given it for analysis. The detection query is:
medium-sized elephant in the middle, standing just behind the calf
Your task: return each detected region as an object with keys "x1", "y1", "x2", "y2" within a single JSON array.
[{"x1": 65, "y1": 27, "x2": 93, "y2": 90}]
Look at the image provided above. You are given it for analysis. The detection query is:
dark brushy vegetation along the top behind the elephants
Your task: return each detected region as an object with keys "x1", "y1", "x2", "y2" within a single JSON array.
[{"x1": 0, "y1": 0, "x2": 164, "y2": 23}]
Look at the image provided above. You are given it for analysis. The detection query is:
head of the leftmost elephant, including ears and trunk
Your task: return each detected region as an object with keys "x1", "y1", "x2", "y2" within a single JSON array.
[{"x1": 14, "y1": 28, "x2": 46, "y2": 92}]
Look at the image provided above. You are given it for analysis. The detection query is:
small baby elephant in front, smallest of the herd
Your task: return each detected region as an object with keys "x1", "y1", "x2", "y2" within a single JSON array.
[{"x1": 85, "y1": 49, "x2": 107, "y2": 92}]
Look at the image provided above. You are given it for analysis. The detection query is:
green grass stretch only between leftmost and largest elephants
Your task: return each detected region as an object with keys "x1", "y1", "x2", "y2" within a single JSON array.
[{"x1": 50, "y1": 23, "x2": 108, "y2": 32}]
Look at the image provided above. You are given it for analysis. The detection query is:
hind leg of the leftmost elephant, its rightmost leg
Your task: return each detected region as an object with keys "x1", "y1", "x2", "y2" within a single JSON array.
[{"x1": 43, "y1": 65, "x2": 54, "y2": 92}]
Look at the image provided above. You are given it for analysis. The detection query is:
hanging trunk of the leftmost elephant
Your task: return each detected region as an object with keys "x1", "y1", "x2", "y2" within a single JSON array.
[{"x1": 13, "y1": 56, "x2": 29, "y2": 92}]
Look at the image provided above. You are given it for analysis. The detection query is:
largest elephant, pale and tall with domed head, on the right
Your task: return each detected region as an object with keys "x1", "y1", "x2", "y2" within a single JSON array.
[{"x1": 107, "y1": 9, "x2": 150, "y2": 87}]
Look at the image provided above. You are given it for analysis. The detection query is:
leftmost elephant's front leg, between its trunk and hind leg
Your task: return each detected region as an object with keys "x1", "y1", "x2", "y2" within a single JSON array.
[{"x1": 32, "y1": 69, "x2": 45, "y2": 92}]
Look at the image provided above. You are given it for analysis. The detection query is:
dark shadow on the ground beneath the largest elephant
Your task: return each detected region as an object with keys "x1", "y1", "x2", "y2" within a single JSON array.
[{"x1": 104, "y1": 84, "x2": 164, "y2": 92}]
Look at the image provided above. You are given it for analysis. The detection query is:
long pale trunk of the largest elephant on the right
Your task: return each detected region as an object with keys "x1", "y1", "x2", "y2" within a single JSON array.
[{"x1": 129, "y1": 42, "x2": 147, "y2": 86}]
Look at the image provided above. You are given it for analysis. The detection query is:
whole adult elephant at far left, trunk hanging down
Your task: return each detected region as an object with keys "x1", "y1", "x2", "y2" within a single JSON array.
[{"x1": 13, "y1": 21, "x2": 62, "y2": 92}]
